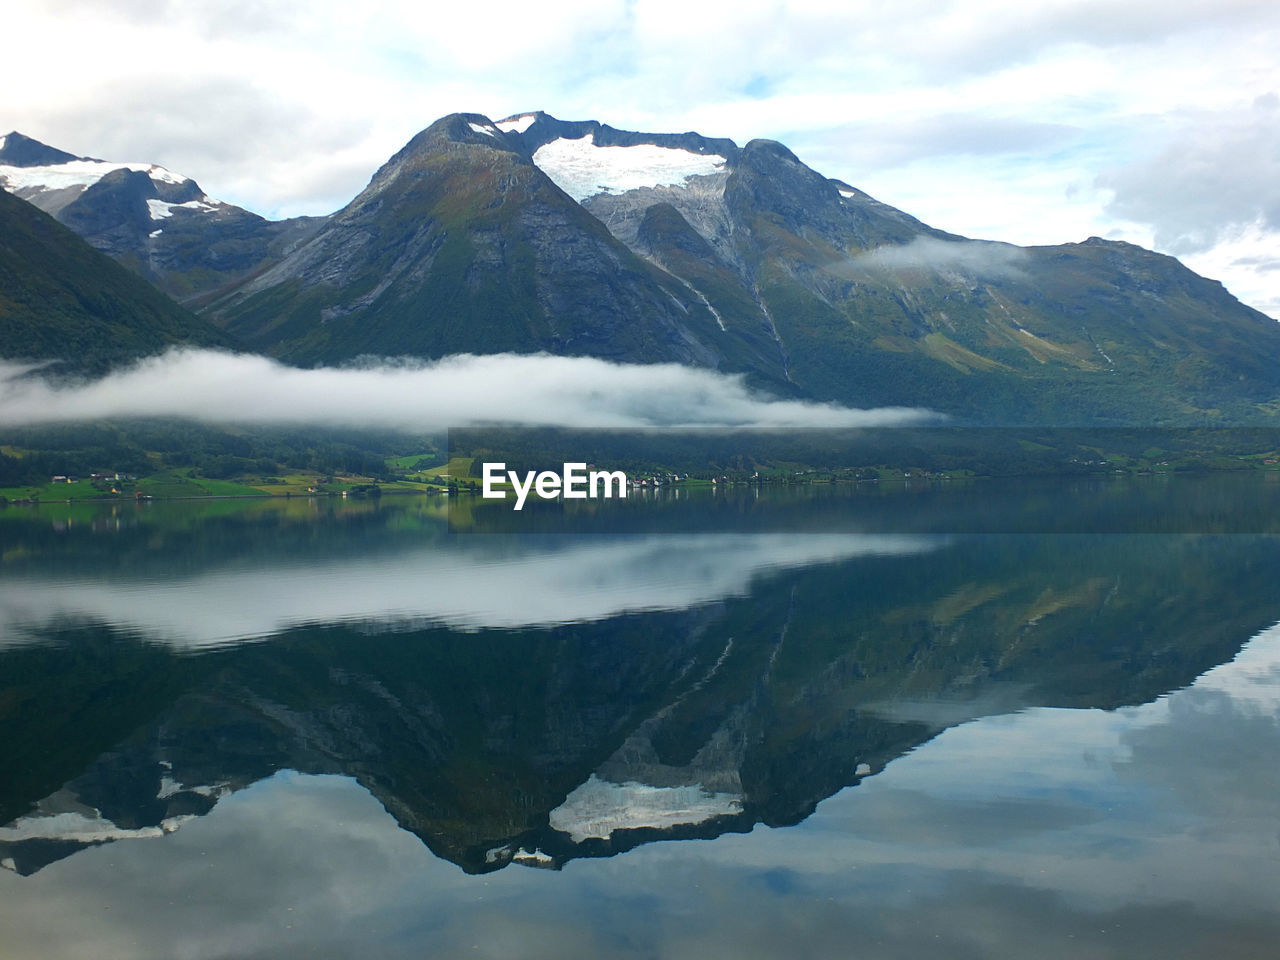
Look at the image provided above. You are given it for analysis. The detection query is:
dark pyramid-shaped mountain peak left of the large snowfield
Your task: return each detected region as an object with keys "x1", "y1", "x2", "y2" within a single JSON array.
[{"x1": 200, "y1": 114, "x2": 785, "y2": 381}]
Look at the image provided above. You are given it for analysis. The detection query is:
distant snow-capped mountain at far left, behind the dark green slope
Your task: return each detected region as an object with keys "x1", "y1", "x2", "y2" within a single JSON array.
[{"x1": 0, "y1": 132, "x2": 321, "y2": 300}]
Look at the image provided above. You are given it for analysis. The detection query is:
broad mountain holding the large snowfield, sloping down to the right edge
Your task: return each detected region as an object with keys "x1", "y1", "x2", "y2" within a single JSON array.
[{"x1": 499, "y1": 114, "x2": 1280, "y2": 422}]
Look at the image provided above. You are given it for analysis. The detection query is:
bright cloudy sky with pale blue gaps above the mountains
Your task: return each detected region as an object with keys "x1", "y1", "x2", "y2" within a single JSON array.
[{"x1": 0, "y1": 0, "x2": 1280, "y2": 317}]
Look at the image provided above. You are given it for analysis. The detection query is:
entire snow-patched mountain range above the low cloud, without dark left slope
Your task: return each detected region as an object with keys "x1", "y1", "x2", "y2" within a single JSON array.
[{"x1": 0, "y1": 113, "x2": 1280, "y2": 424}]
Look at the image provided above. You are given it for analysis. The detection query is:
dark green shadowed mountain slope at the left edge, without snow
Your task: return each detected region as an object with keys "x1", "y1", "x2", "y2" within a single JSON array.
[{"x1": 0, "y1": 191, "x2": 230, "y2": 372}]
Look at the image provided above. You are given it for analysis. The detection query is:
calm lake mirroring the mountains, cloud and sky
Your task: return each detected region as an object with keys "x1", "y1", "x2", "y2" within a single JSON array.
[{"x1": 0, "y1": 481, "x2": 1280, "y2": 960}]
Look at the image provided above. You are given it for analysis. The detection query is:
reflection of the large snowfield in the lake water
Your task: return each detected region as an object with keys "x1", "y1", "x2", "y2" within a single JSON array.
[{"x1": 550, "y1": 773, "x2": 742, "y2": 844}]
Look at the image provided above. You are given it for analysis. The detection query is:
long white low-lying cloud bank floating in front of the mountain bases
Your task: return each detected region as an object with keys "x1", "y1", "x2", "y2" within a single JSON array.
[{"x1": 0, "y1": 349, "x2": 937, "y2": 430}]
